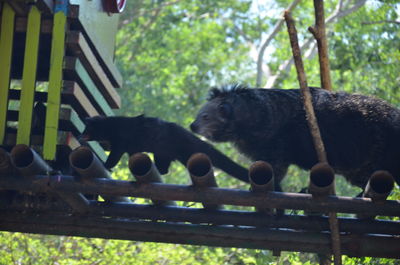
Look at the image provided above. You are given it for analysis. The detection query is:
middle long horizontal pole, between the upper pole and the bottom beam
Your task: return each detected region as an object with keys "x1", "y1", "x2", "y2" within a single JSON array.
[{"x1": 0, "y1": 196, "x2": 400, "y2": 235}]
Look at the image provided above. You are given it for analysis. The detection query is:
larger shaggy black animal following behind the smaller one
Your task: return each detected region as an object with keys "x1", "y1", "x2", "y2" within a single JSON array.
[{"x1": 191, "y1": 85, "x2": 400, "y2": 190}]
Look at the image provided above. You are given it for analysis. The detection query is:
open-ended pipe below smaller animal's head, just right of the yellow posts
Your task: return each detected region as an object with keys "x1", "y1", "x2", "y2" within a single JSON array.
[{"x1": 69, "y1": 146, "x2": 130, "y2": 202}]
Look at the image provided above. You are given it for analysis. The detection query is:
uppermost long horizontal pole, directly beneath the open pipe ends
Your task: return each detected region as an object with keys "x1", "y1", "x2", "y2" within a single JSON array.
[{"x1": 0, "y1": 176, "x2": 400, "y2": 216}]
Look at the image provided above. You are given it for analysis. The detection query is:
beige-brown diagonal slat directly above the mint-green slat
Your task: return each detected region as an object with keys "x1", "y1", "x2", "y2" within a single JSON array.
[{"x1": 66, "y1": 31, "x2": 121, "y2": 108}]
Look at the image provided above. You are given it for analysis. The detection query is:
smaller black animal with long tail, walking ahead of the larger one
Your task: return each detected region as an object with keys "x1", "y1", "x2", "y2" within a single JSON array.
[{"x1": 80, "y1": 115, "x2": 248, "y2": 182}]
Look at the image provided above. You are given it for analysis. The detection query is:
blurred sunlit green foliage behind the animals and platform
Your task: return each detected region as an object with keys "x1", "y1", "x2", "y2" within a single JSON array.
[{"x1": 0, "y1": 0, "x2": 400, "y2": 265}]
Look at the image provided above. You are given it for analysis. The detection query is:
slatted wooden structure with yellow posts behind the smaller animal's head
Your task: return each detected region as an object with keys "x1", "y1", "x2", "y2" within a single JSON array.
[{"x1": 0, "y1": 0, "x2": 122, "y2": 163}]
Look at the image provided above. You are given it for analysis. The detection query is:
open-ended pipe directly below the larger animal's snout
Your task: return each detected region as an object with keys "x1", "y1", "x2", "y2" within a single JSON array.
[{"x1": 186, "y1": 153, "x2": 223, "y2": 210}]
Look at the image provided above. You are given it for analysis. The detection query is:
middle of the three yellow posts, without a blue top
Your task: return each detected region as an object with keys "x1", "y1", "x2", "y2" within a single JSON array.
[{"x1": 17, "y1": 5, "x2": 41, "y2": 145}]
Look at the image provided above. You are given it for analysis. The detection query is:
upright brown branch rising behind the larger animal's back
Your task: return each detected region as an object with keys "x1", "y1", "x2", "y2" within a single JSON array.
[{"x1": 308, "y1": 0, "x2": 332, "y2": 90}]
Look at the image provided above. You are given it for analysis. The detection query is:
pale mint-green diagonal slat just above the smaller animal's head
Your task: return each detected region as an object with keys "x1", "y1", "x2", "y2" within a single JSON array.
[{"x1": 64, "y1": 56, "x2": 114, "y2": 116}]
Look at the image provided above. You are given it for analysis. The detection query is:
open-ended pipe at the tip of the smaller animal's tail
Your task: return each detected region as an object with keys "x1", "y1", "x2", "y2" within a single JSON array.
[{"x1": 249, "y1": 161, "x2": 274, "y2": 214}]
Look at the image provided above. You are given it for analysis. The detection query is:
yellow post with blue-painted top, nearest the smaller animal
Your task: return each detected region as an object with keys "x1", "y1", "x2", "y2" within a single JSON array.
[{"x1": 43, "y1": 1, "x2": 68, "y2": 160}]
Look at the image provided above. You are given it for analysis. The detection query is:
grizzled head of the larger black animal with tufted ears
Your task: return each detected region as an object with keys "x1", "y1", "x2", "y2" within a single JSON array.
[{"x1": 190, "y1": 85, "x2": 248, "y2": 142}]
